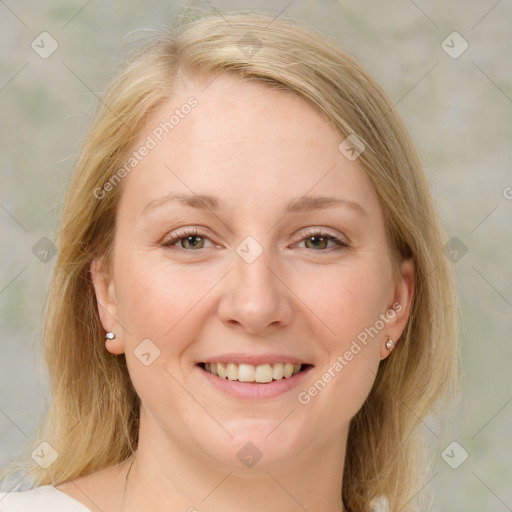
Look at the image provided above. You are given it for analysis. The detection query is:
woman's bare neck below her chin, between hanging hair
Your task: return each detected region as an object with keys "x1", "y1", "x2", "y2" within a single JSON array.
[{"x1": 122, "y1": 418, "x2": 346, "y2": 512}]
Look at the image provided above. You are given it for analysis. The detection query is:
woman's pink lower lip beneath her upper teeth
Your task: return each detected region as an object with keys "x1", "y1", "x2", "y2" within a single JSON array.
[{"x1": 197, "y1": 366, "x2": 313, "y2": 400}]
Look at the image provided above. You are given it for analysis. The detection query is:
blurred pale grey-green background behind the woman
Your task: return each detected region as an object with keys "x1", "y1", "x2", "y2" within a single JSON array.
[{"x1": 0, "y1": 0, "x2": 512, "y2": 512}]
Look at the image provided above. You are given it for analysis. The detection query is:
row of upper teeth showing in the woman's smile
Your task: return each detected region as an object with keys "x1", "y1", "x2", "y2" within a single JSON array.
[{"x1": 204, "y1": 363, "x2": 301, "y2": 382}]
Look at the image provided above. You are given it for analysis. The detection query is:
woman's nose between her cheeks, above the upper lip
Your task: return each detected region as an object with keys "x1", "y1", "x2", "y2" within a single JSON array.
[{"x1": 218, "y1": 245, "x2": 294, "y2": 335}]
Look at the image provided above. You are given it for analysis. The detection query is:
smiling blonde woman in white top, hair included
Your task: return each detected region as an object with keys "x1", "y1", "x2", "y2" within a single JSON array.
[{"x1": 0, "y1": 9, "x2": 458, "y2": 512}]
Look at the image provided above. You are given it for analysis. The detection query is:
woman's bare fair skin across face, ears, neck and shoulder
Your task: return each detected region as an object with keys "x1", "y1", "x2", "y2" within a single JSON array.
[{"x1": 58, "y1": 75, "x2": 414, "y2": 512}]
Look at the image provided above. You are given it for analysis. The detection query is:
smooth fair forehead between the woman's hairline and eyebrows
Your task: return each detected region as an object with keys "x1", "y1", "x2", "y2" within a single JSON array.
[{"x1": 116, "y1": 74, "x2": 378, "y2": 220}]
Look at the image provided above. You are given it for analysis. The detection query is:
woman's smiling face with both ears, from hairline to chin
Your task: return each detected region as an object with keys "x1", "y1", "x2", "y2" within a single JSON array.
[{"x1": 93, "y1": 75, "x2": 413, "y2": 467}]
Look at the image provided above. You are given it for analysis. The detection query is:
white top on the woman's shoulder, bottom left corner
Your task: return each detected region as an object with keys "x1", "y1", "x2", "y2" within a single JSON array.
[{"x1": 0, "y1": 485, "x2": 91, "y2": 512}]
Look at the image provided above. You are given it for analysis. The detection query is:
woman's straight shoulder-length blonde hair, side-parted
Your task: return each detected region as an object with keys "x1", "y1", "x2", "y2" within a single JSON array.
[{"x1": 0, "y1": 11, "x2": 459, "y2": 511}]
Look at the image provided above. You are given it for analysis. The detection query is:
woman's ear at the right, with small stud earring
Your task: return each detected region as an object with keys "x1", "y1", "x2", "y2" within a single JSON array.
[{"x1": 380, "y1": 258, "x2": 416, "y2": 359}]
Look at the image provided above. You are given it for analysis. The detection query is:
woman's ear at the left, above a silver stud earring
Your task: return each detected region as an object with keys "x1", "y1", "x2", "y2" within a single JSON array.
[{"x1": 91, "y1": 258, "x2": 124, "y2": 354}]
